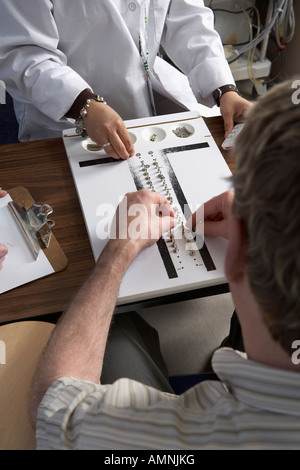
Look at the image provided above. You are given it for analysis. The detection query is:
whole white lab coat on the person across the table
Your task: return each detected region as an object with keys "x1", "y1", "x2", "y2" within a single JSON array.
[{"x1": 0, "y1": 0, "x2": 234, "y2": 141}]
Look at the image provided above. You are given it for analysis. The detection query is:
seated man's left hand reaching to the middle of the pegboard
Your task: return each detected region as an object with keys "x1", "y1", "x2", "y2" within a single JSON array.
[{"x1": 110, "y1": 189, "x2": 175, "y2": 256}]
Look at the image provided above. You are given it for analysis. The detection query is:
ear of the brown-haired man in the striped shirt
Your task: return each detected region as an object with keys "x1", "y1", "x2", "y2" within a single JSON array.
[{"x1": 225, "y1": 217, "x2": 246, "y2": 282}]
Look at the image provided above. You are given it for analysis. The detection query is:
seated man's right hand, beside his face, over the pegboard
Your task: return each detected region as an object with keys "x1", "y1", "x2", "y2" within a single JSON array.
[{"x1": 192, "y1": 191, "x2": 234, "y2": 239}]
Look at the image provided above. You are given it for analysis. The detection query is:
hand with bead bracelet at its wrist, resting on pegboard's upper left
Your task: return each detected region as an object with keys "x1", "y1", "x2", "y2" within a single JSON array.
[{"x1": 83, "y1": 100, "x2": 135, "y2": 160}]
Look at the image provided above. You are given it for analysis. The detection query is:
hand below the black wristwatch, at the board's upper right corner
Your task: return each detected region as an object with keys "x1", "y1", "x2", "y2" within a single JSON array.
[{"x1": 220, "y1": 91, "x2": 252, "y2": 138}]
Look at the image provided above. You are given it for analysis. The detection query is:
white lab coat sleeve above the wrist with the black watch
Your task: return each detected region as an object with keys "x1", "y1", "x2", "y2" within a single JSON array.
[{"x1": 162, "y1": 0, "x2": 235, "y2": 106}]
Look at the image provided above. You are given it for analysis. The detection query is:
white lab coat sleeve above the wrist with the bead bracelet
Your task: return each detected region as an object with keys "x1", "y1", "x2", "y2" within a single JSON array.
[{"x1": 0, "y1": 0, "x2": 90, "y2": 121}]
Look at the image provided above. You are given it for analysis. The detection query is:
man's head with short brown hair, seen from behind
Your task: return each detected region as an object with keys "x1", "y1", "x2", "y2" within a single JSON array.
[{"x1": 233, "y1": 81, "x2": 300, "y2": 352}]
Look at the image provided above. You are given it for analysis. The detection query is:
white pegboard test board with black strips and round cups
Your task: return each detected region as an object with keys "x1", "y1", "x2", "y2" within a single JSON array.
[{"x1": 63, "y1": 112, "x2": 231, "y2": 305}]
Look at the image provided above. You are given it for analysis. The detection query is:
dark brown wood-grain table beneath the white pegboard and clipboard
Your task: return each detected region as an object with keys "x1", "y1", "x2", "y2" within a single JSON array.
[{"x1": 0, "y1": 117, "x2": 234, "y2": 322}]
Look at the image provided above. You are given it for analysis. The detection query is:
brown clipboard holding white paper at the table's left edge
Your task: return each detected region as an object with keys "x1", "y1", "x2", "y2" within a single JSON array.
[{"x1": 0, "y1": 186, "x2": 68, "y2": 294}]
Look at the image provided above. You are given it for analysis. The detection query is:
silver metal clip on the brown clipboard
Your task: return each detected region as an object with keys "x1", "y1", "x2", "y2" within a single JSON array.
[{"x1": 8, "y1": 201, "x2": 55, "y2": 259}]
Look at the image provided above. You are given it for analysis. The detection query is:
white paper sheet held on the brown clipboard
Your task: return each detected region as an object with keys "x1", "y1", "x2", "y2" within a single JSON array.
[{"x1": 0, "y1": 195, "x2": 54, "y2": 294}]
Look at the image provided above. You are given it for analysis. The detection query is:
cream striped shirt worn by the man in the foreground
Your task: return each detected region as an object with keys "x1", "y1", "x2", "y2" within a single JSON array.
[{"x1": 36, "y1": 348, "x2": 300, "y2": 450}]
